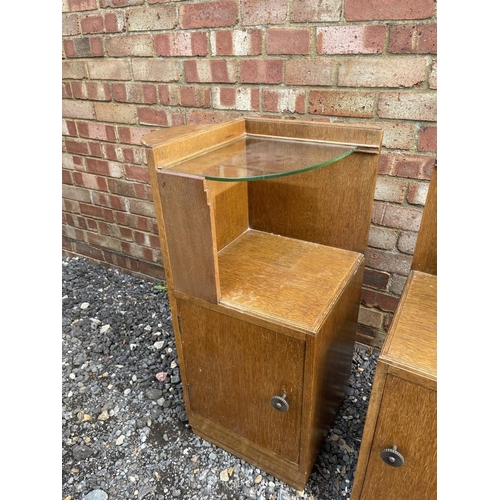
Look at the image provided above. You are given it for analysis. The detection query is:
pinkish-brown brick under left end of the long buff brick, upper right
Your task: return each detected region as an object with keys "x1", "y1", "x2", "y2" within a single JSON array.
[{"x1": 309, "y1": 90, "x2": 377, "y2": 118}]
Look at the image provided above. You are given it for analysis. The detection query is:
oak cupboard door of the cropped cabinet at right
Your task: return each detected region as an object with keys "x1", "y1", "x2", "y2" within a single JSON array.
[{"x1": 361, "y1": 375, "x2": 437, "y2": 500}]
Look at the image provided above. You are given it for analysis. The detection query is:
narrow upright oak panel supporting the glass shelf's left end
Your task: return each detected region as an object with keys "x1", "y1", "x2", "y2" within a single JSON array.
[{"x1": 158, "y1": 170, "x2": 220, "y2": 302}]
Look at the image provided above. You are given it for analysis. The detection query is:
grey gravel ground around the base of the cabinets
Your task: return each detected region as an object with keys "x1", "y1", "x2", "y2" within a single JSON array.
[{"x1": 62, "y1": 258, "x2": 377, "y2": 500}]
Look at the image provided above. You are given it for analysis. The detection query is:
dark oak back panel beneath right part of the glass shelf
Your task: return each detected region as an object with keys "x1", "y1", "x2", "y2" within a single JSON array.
[{"x1": 248, "y1": 153, "x2": 379, "y2": 253}]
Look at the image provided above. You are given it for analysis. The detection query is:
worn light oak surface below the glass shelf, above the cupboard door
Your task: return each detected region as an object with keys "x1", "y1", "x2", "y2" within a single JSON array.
[{"x1": 219, "y1": 230, "x2": 362, "y2": 333}]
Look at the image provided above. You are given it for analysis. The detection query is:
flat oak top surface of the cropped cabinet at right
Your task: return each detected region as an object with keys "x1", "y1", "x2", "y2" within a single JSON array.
[{"x1": 379, "y1": 271, "x2": 437, "y2": 382}]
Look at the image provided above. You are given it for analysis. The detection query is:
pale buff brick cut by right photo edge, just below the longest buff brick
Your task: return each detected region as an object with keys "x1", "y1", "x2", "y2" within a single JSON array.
[{"x1": 378, "y1": 91, "x2": 437, "y2": 121}]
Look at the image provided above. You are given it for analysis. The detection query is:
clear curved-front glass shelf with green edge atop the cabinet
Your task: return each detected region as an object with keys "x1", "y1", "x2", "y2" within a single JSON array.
[{"x1": 160, "y1": 134, "x2": 356, "y2": 182}]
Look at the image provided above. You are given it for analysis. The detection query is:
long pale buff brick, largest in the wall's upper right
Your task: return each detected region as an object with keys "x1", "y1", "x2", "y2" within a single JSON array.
[{"x1": 338, "y1": 57, "x2": 427, "y2": 87}]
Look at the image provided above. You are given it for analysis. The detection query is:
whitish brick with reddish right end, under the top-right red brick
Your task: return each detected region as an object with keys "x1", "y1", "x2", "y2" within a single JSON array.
[{"x1": 316, "y1": 24, "x2": 386, "y2": 54}]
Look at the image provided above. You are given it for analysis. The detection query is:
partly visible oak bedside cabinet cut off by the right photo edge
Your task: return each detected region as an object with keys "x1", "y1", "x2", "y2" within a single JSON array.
[{"x1": 351, "y1": 169, "x2": 437, "y2": 500}]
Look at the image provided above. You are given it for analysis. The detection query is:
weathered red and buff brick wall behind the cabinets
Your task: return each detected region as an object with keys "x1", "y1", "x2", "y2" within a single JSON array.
[{"x1": 62, "y1": 0, "x2": 437, "y2": 347}]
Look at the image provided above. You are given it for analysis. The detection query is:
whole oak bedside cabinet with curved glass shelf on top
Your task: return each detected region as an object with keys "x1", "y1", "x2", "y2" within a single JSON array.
[{"x1": 143, "y1": 118, "x2": 382, "y2": 489}]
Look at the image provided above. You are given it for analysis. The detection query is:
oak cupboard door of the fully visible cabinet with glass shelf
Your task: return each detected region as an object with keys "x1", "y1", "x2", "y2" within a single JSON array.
[{"x1": 179, "y1": 301, "x2": 305, "y2": 463}]
